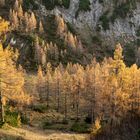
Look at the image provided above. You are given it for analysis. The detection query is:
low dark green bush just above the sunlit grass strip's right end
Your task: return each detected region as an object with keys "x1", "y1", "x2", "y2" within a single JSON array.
[{"x1": 71, "y1": 122, "x2": 89, "y2": 133}]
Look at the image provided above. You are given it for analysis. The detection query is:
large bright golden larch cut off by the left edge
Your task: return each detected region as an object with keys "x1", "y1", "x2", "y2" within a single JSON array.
[{"x1": 0, "y1": 19, "x2": 28, "y2": 122}]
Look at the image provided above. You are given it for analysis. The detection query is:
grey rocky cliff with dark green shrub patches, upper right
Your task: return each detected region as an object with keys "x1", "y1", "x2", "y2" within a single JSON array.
[{"x1": 37, "y1": 0, "x2": 140, "y2": 43}]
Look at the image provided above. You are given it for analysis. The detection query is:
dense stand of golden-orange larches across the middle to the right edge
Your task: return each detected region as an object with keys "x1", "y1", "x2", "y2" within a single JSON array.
[{"x1": 36, "y1": 44, "x2": 140, "y2": 125}]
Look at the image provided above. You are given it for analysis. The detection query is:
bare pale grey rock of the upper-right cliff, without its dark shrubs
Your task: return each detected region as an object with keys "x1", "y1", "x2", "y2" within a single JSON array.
[{"x1": 38, "y1": 0, "x2": 140, "y2": 42}]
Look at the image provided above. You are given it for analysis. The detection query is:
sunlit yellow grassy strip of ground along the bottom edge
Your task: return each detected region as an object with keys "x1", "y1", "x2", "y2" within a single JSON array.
[{"x1": 0, "y1": 126, "x2": 89, "y2": 140}]
